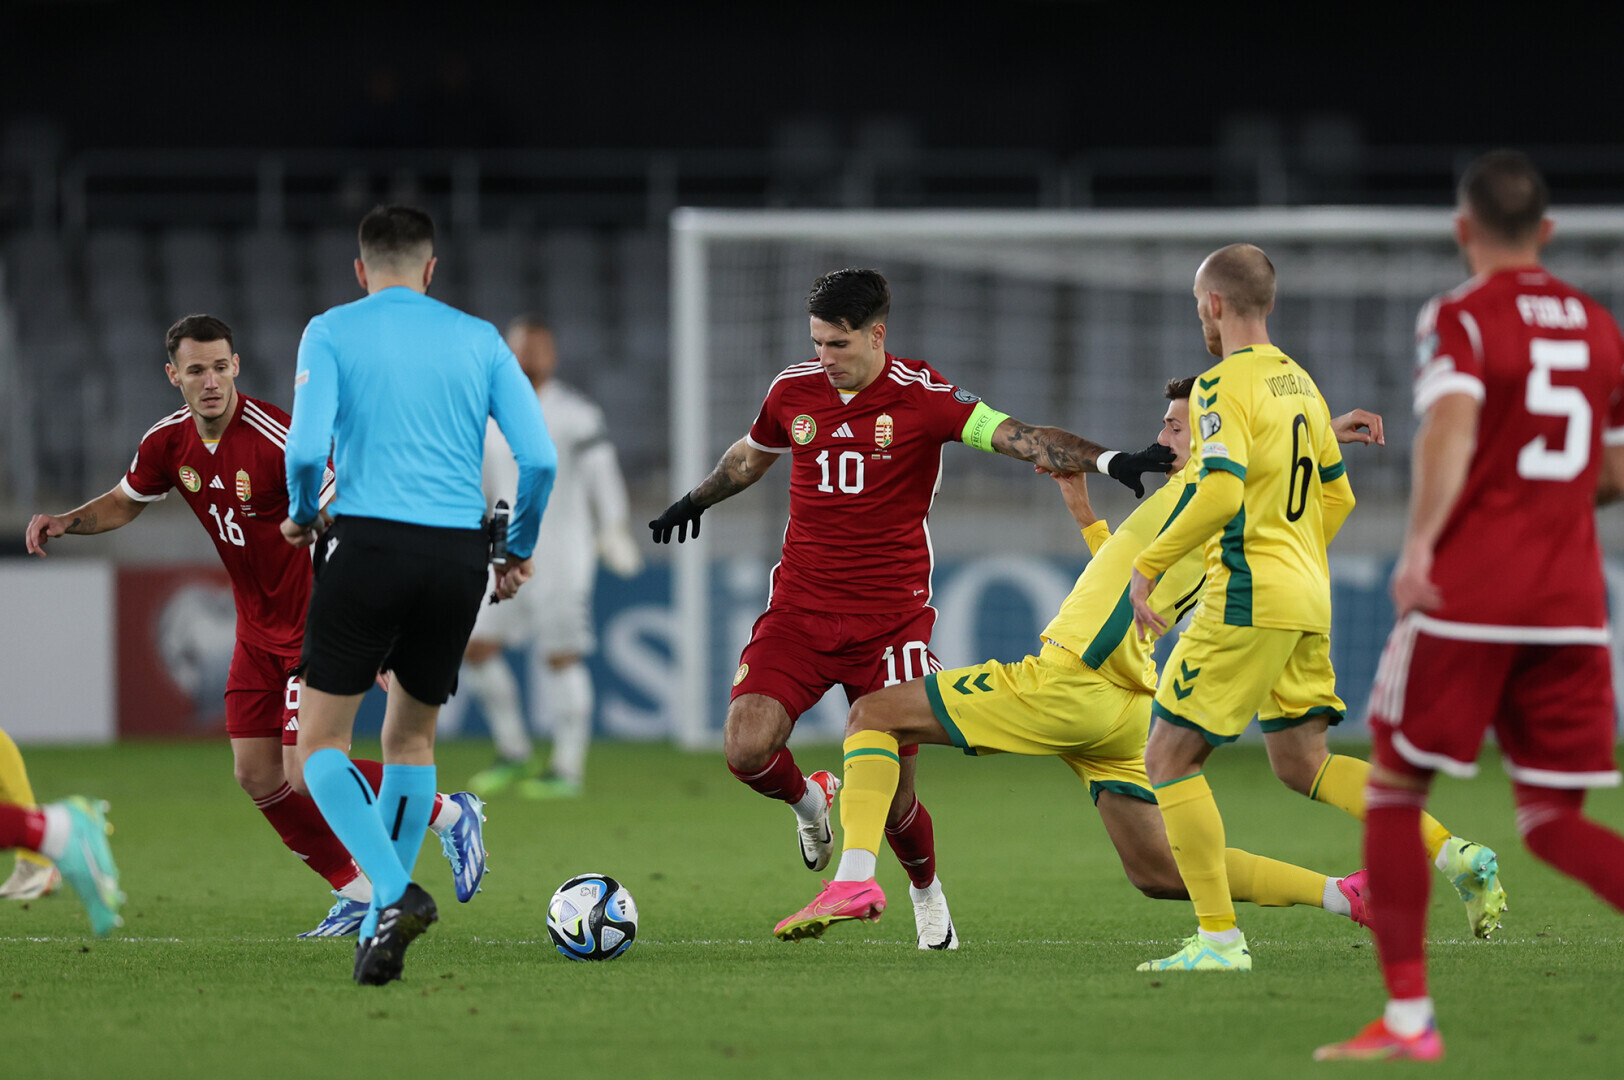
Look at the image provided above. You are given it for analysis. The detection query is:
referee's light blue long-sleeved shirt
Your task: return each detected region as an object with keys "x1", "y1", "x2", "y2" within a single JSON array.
[{"x1": 287, "y1": 286, "x2": 559, "y2": 559}]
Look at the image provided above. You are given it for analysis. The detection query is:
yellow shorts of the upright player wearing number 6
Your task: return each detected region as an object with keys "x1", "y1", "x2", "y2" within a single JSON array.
[{"x1": 1151, "y1": 619, "x2": 1346, "y2": 745}]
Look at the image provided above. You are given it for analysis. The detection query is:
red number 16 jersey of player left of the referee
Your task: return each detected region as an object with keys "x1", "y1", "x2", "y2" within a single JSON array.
[{"x1": 122, "y1": 391, "x2": 331, "y2": 653}]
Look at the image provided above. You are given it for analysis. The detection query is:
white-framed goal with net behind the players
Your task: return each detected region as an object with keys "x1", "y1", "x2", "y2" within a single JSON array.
[{"x1": 671, "y1": 208, "x2": 1624, "y2": 745}]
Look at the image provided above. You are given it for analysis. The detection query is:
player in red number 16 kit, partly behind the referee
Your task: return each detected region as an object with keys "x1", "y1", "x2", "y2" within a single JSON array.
[{"x1": 26, "y1": 315, "x2": 484, "y2": 937}]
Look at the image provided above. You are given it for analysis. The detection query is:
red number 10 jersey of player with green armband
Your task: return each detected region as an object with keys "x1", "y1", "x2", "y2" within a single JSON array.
[{"x1": 749, "y1": 352, "x2": 979, "y2": 614}]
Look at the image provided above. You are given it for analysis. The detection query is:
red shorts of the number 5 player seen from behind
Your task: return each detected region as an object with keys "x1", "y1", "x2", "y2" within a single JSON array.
[{"x1": 1371, "y1": 617, "x2": 1619, "y2": 788}]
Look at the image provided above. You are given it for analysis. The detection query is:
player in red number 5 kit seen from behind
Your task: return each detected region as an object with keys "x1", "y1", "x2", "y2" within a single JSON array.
[{"x1": 1315, "y1": 151, "x2": 1624, "y2": 1061}]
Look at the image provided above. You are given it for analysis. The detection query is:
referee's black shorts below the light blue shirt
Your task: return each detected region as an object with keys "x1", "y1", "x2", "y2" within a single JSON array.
[{"x1": 300, "y1": 516, "x2": 489, "y2": 705}]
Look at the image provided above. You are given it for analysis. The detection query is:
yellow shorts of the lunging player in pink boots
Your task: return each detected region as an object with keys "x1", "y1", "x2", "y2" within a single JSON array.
[{"x1": 924, "y1": 645, "x2": 1156, "y2": 802}]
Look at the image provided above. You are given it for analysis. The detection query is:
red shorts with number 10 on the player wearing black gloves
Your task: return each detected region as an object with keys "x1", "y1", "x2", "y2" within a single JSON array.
[{"x1": 729, "y1": 607, "x2": 942, "y2": 723}]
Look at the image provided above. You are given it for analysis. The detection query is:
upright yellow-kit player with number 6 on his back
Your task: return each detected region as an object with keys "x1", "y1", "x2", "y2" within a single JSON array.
[{"x1": 1129, "y1": 244, "x2": 1505, "y2": 971}]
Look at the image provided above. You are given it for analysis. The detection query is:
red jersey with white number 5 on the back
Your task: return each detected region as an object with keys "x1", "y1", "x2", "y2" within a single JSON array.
[{"x1": 1415, "y1": 268, "x2": 1624, "y2": 626}]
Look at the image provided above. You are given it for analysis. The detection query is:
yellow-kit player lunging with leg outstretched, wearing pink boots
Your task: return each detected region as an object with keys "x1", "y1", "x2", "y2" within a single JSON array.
[{"x1": 775, "y1": 378, "x2": 1380, "y2": 948}]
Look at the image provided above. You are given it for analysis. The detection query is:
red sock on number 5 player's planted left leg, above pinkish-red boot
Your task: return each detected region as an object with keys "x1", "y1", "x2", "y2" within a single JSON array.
[{"x1": 1364, "y1": 781, "x2": 1432, "y2": 1000}]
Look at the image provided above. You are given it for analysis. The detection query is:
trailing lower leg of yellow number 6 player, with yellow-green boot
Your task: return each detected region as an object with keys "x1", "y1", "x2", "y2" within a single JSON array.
[{"x1": 1292, "y1": 750, "x2": 1507, "y2": 939}]
